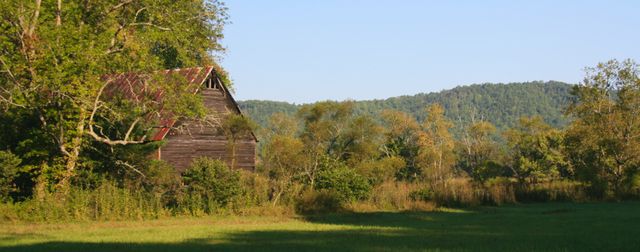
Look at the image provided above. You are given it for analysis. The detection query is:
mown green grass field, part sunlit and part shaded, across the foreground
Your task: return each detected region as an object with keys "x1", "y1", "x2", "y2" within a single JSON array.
[{"x1": 0, "y1": 202, "x2": 640, "y2": 252}]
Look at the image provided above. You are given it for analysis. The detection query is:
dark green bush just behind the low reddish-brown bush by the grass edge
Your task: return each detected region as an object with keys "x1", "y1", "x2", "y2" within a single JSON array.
[{"x1": 315, "y1": 167, "x2": 371, "y2": 202}]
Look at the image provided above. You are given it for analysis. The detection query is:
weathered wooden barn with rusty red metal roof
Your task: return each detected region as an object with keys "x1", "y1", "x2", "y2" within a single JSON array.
[{"x1": 113, "y1": 66, "x2": 257, "y2": 172}]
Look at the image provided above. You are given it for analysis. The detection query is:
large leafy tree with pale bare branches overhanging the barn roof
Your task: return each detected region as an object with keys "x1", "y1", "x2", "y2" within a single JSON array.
[{"x1": 0, "y1": 0, "x2": 227, "y2": 188}]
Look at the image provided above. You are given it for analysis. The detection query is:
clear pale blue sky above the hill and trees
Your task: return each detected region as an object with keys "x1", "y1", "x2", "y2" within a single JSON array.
[{"x1": 221, "y1": 0, "x2": 640, "y2": 104}]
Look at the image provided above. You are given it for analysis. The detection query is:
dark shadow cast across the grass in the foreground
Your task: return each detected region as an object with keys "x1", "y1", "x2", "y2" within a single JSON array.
[{"x1": 0, "y1": 205, "x2": 640, "y2": 252}]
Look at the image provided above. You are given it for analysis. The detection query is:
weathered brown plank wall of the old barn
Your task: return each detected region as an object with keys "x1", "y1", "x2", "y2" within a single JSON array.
[{"x1": 159, "y1": 83, "x2": 256, "y2": 172}]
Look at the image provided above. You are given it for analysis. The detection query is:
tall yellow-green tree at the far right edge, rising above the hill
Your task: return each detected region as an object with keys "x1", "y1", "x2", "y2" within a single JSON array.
[{"x1": 567, "y1": 60, "x2": 640, "y2": 197}]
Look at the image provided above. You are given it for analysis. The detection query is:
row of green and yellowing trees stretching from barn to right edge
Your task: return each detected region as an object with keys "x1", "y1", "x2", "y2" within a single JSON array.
[{"x1": 262, "y1": 60, "x2": 640, "y2": 211}]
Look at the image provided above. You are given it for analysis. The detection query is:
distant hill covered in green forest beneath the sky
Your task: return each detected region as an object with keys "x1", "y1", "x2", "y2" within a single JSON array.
[{"x1": 239, "y1": 81, "x2": 572, "y2": 132}]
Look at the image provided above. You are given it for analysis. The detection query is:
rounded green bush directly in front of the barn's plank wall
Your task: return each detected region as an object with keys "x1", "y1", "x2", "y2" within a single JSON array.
[{"x1": 181, "y1": 158, "x2": 242, "y2": 213}]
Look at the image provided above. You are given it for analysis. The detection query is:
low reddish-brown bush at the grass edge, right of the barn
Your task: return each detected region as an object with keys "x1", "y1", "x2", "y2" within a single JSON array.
[{"x1": 295, "y1": 190, "x2": 344, "y2": 214}]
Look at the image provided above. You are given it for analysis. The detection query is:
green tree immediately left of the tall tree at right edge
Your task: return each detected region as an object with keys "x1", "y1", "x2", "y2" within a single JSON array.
[{"x1": 505, "y1": 116, "x2": 570, "y2": 185}]
